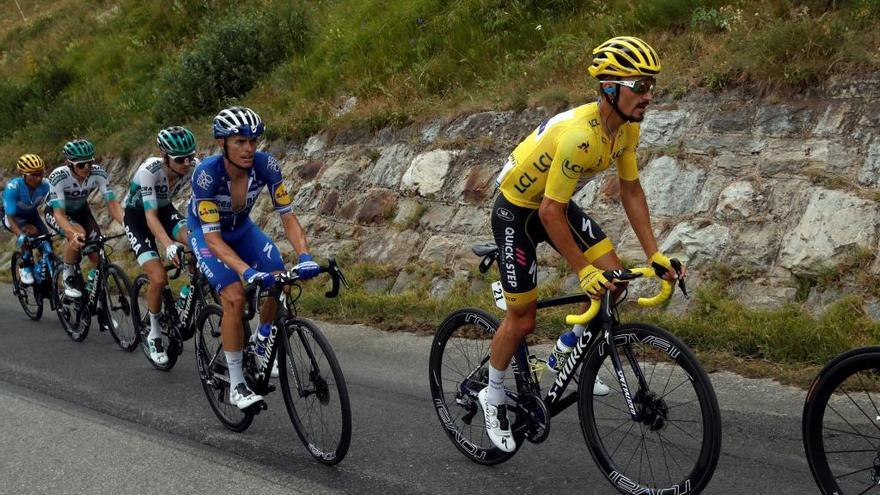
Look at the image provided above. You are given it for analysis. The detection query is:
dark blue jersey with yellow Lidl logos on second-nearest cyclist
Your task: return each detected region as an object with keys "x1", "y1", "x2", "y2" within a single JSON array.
[{"x1": 189, "y1": 152, "x2": 292, "y2": 233}]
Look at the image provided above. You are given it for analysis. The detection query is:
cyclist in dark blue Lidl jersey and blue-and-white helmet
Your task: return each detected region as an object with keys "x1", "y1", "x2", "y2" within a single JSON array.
[{"x1": 187, "y1": 107, "x2": 320, "y2": 409}]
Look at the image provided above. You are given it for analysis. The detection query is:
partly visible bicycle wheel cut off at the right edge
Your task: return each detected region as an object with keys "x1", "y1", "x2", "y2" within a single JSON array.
[{"x1": 801, "y1": 346, "x2": 880, "y2": 495}]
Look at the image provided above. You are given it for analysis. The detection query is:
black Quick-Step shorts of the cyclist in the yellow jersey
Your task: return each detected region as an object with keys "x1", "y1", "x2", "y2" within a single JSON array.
[{"x1": 492, "y1": 194, "x2": 614, "y2": 305}]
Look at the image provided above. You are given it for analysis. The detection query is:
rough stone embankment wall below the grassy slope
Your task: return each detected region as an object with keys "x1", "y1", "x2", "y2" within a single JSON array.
[{"x1": 13, "y1": 77, "x2": 880, "y2": 312}]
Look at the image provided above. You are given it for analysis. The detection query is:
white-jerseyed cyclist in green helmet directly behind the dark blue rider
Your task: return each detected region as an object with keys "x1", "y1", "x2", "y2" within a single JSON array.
[{"x1": 122, "y1": 126, "x2": 196, "y2": 365}]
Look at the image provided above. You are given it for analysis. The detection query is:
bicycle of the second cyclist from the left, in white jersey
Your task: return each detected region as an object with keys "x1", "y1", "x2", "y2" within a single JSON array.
[{"x1": 55, "y1": 234, "x2": 138, "y2": 352}]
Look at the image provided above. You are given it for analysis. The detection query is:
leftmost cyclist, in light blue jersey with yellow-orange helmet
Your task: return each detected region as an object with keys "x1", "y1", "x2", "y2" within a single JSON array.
[{"x1": 3, "y1": 154, "x2": 52, "y2": 284}]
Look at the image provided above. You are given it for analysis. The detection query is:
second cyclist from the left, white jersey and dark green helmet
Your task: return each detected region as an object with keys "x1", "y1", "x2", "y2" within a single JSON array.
[{"x1": 44, "y1": 139, "x2": 122, "y2": 297}]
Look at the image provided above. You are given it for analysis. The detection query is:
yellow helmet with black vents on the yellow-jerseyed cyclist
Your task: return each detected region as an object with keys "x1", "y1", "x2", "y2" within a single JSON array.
[{"x1": 588, "y1": 36, "x2": 660, "y2": 78}]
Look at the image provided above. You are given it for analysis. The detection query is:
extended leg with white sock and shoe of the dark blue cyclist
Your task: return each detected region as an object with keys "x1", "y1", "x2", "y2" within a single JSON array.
[{"x1": 188, "y1": 215, "x2": 263, "y2": 409}]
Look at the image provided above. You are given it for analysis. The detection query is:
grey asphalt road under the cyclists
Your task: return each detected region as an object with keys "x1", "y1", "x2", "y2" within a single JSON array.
[{"x1": 0, "y1": 285, "x2": 817, "y2": 494}]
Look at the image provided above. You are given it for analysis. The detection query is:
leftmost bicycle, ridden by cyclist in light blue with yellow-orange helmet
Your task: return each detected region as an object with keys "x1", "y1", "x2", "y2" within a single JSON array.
[{"x1": 10, "y1": 234, "x2": 61, "y2": 321}]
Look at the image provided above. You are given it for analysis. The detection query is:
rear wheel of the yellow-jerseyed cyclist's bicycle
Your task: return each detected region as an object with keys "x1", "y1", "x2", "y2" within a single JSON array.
[{"x1": 428, "y1": 308, "x2": 529, "y2": 465}]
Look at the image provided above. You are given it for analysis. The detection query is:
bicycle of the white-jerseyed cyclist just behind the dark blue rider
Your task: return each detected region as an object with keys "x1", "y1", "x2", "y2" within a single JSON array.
[{"x1": 131, "y1": 251, "x2": 218, "y2": 371}]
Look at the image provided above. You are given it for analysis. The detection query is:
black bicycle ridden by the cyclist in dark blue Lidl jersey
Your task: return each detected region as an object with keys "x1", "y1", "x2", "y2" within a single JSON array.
[{"x1": 196, "y1": 258, "x2": 351, "y2": 465}]
